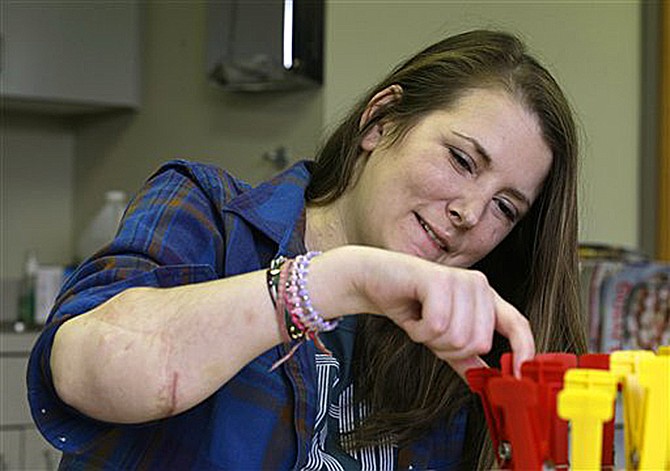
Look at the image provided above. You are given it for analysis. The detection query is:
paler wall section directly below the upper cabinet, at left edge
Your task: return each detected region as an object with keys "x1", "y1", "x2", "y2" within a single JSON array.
[{"x1": 0, "y1": 113, "x2": 74, "y2": 278}]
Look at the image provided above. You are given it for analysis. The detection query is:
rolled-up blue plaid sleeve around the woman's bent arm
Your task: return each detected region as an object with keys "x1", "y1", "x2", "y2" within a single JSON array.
[{"x1": 27, "y1": 161, "x2": 225, "y2": 453}]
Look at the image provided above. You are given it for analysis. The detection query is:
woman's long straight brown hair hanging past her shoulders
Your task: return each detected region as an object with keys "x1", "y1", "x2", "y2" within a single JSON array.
[{"x1": 307, "y1": 30, "x2": 586, "y2": 468}]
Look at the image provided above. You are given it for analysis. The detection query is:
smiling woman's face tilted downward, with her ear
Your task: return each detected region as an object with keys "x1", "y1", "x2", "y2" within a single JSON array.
[{"x1": 343, "y1": 89, "x2": 552, "y2": 267}]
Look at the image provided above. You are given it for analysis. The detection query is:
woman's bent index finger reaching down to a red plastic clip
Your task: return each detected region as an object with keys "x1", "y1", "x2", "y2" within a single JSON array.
[{"x1": 494, "y1": 293, "x2": 535, "y2": 378}]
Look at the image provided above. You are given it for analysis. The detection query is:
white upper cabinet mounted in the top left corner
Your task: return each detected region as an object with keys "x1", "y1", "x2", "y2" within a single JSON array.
[{"x1": 0, "y1": 0, "x2": 140, "y2": 113}]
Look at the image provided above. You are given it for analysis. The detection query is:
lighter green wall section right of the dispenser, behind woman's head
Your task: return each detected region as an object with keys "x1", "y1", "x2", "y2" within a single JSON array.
[{"x1": 324, "y1": 0, "x2": 642, "y2": 248}]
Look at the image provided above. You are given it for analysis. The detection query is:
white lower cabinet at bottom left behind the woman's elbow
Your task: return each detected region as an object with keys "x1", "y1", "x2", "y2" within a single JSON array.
[{"x1": 0, "y1": 332, "x2": 60, "y2": 470}]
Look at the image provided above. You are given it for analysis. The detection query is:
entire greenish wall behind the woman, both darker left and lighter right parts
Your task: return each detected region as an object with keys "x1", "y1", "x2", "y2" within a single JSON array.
[{"x1": 0, "y1": 0, "x2": 642, "y2": 288}]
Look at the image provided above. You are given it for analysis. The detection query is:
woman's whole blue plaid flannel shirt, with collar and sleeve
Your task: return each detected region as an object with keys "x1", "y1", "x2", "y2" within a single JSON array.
[{"x1": 27, "y1": 160, "x2": 465, "y2": 471}]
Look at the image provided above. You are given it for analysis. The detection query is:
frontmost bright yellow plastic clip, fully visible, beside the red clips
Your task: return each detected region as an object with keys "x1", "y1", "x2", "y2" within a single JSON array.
[{"x1": 557, "y1": 369, "x2": 617, "y2": 471}]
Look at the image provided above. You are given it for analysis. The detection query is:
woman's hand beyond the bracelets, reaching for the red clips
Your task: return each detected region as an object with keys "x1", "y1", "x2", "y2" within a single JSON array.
[{"x1": 310, "y1": 246, "x2": 535, "y2": 376}]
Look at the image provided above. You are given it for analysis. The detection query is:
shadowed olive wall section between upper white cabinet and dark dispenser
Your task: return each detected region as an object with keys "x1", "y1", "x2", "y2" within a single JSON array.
[{"x1": 74, "y1": 2, "x2": 323, "y2": 240}]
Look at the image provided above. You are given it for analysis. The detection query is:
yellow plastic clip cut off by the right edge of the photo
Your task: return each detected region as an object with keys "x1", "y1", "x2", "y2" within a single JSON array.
[{"x1": 634, "y1": 355, "x2": 670, "y2": 470}]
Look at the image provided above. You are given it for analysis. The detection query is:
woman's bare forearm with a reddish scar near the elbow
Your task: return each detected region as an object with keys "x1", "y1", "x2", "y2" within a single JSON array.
[{"x1": 51, "y1": 271, "x2": 281, "y2": 423}]
